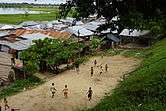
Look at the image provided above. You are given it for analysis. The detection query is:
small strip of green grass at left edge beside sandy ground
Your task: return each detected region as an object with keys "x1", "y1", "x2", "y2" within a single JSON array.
[{"x1": 0, "y1": 76, "x2": 43, "y2": 99}]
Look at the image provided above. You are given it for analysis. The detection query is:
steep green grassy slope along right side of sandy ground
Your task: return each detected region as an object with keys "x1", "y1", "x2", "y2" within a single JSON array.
[{"x1": 82, "y1": 39, "x2": 166, "y2": 111}]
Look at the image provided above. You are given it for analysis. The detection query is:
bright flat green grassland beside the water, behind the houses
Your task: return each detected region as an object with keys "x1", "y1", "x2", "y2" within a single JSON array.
[{"x1": 0, "y1": 7, "x2": 75, "y2": 24}]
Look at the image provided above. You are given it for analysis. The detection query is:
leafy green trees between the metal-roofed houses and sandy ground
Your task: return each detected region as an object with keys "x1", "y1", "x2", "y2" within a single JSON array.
[{"x1": 21, "y1": 38, "x2": 84, "y2": 73}]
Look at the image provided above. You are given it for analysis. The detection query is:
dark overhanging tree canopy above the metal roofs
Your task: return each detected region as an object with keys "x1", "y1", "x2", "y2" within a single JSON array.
[{"x1": 59, "y1": 0, "x2": 166, "y2": 33}]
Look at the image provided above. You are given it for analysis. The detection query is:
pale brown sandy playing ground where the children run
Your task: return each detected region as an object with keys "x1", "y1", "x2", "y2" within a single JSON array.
[{"x1": 0, "y1": 56, "x2": 140, "y2": 111}]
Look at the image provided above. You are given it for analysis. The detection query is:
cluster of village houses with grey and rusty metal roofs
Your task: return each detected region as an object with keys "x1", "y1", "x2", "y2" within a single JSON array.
[{"x1": 0, "y1": 15, "x2": 153, "y2": 84}]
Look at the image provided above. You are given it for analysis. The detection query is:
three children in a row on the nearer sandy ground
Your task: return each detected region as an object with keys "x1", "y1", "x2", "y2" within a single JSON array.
[{"x1": 50, "y1": 83, "x2": 93, "y2": 101}]
